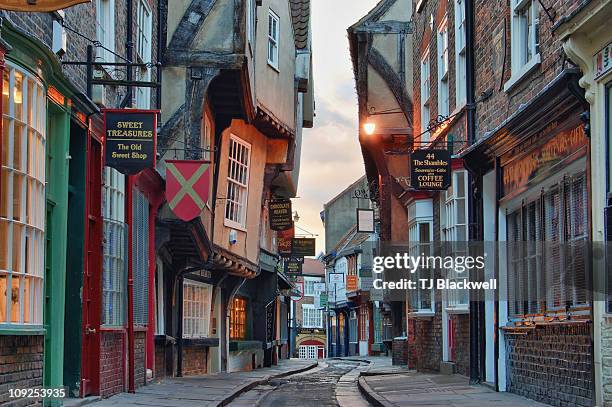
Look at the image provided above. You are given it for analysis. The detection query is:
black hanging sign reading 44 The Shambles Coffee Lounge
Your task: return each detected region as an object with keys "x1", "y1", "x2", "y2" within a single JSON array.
[{"x1": 410, "y1": 149, "x2": 451, "y2": 191}]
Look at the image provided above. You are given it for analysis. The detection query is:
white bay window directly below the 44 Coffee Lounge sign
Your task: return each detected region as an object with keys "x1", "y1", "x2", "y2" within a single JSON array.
[{"x1": 408, "y1": 200, "x2": 435, "y2": 313}]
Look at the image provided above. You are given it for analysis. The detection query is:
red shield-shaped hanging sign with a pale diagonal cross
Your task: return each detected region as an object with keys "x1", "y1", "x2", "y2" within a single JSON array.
[{"x1": 166, "y1": 160, "x2": 210, "y2": 222}]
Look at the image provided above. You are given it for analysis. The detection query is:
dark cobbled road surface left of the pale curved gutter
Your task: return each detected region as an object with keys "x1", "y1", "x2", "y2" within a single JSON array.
[{"x1": 229, "y1": 360, "x2": 365, "y2": 407}]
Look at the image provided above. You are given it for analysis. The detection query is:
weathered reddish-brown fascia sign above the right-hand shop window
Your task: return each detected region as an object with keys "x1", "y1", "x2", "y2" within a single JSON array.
[{"x1": 501, "y1": 122, "x2": 588, "y2": 196}]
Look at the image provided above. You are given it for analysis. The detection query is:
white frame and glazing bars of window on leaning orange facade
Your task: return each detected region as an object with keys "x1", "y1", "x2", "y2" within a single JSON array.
[{"x1": 224, "y1": 134, "x2": 251, "y2": 231}]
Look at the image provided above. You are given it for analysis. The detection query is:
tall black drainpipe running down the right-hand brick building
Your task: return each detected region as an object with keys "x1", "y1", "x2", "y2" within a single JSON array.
[{"x1": 465, "y1": 0, "x2": 480, "y2": 383}]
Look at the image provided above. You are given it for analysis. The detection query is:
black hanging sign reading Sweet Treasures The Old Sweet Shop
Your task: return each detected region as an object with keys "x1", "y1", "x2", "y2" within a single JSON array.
[{"x1": 104, "y1": 109, "x2": 158, "y2": 174}]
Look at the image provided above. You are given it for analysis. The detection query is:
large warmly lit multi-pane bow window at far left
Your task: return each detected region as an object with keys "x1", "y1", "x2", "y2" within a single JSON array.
[{"x1": 0, "y1": 63, "x2": 47, "y2": 326}]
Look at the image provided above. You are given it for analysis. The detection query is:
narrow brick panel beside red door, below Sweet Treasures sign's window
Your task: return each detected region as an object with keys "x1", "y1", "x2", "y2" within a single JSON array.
[{"x1": 100, "y1": 332, "x2": 127, "y2": 397}]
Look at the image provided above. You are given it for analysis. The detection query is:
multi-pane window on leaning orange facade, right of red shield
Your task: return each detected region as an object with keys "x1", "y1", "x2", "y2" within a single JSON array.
[{"x1": 225, "y1": 136, "x2": 251, "y2": 228}]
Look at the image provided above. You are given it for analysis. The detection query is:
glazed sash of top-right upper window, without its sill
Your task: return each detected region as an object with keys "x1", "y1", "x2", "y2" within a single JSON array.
[{"x1": 511, "y1": 0, "x2": 539, "y2": 75}]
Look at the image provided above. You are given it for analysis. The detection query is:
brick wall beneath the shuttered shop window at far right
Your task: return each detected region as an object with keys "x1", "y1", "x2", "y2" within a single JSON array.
[{"x1": 506, "y1": 324, "x2": 594, "y2": 407}]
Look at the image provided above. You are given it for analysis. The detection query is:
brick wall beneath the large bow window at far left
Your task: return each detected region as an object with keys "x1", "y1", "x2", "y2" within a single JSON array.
[{"x1": 0, "y1": 335, "x2": 44, "y2": 407}]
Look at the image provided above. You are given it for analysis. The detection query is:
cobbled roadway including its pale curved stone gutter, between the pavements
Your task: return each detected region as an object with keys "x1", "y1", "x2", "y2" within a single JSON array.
[{"x1": 228, "y1": 359, "x2": 370, "y2": 407}]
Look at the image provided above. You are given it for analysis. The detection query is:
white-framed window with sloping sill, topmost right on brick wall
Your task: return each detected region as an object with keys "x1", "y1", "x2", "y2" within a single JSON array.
[{"x1": 504, "y1": 0, "x2": 541, "y2": 92}]
